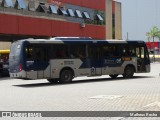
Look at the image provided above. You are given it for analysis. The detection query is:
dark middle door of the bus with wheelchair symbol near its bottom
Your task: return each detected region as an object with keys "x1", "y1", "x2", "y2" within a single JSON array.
[{"x1": 88, "y1": 45, "x2": 103, "y2": 76}]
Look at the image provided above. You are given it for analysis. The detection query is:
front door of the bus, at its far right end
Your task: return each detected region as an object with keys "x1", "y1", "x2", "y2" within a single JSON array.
[{"x1": 136, "y1": 46, "x2": 150, "y2": 72}]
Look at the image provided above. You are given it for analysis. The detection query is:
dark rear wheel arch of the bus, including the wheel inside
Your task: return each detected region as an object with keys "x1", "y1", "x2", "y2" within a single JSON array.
[{"x1": 59, "y1": 67, "x2": 74, "y2": 83}]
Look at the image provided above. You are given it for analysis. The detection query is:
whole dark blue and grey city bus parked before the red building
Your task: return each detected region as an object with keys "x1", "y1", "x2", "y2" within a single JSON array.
[{"x1": 9, "y1": 37, "x2": 150, "y2": 83}]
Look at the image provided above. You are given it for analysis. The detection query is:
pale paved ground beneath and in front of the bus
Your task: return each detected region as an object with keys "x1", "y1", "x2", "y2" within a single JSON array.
[{"x1": 0, "y1": 63, "x2": 160, "y2": 119}]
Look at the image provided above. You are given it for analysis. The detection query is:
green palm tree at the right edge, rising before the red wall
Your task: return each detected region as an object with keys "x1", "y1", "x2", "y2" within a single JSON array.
[{"x1": 146, "y1": 26, "x2": 160, "y2": 62}]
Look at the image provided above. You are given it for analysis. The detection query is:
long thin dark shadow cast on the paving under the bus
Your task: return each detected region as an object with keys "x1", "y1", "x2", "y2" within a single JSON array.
[{"x1": 13, "y1": 76, "x2": 154, "y2": 88}]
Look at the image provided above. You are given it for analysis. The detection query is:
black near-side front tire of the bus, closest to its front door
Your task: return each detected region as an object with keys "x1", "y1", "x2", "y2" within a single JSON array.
[{"x1": 123, "y1": 66, "x2": 134, "y2": 78}]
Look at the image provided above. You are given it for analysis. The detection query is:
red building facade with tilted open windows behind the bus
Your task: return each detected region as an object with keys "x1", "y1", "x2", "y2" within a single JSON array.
[{"x1": 0, "y1": 0, "x2": 122, "y2": 49}]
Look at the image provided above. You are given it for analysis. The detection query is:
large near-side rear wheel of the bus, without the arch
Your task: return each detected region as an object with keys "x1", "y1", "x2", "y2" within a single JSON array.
[{"x1": 60, "y1": 69, "x2": 73, "y2": 83}]
